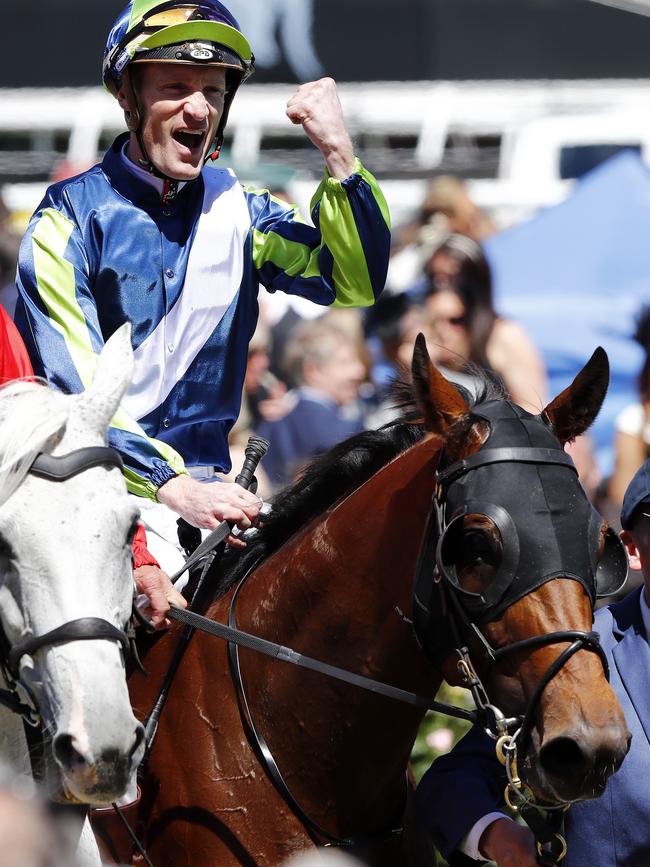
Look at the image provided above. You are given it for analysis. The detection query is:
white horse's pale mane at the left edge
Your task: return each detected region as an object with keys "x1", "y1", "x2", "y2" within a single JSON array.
[{"x1": 0, "y1": 380, "x2": 70, "y2": 505}]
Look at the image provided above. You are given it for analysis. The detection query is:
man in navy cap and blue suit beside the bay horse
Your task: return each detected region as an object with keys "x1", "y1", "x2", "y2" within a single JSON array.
[{"x1": 417, "y1": 461, "x2": 650, "y2": 867}]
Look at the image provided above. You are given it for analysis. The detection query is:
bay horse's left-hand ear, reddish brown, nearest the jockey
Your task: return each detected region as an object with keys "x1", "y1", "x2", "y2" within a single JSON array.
[{"x1": 411, "y1": 334, "x2": 469, "y2": 437}]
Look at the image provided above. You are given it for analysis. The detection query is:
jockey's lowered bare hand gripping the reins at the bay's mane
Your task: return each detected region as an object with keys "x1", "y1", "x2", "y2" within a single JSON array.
[{"x1": 157, "y1": 475, "x2": 263, "y2": 547}]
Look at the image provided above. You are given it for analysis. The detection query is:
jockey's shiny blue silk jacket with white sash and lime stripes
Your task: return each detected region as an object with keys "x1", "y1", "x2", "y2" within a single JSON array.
[{"x1": 16, "y1": 135, "x2": 390, "y2": 499}]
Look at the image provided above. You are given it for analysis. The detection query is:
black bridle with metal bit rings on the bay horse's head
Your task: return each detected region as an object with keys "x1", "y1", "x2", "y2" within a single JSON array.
[{"x1": 413, "y1": 446, "x2": 627, "y2": 865}]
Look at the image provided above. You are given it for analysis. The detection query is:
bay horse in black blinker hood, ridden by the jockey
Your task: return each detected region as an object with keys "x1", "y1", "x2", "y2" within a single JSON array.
[{"x1": 123, "y1": 335, "x2": 629, "y2": 867}]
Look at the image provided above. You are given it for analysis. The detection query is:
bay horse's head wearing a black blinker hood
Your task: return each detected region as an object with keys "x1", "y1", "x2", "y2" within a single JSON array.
[{"x1": 413, "y1": 340, "x2": 630, "y2": 802}]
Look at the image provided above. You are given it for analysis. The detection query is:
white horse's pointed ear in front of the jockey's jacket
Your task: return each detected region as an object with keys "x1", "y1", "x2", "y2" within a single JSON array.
[{"x1": 82, "y1": 322, "x2": 133, "y2": 432}]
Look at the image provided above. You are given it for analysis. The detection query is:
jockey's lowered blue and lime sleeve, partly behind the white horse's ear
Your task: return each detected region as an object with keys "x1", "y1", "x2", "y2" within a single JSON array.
[{"x1": 16, "y1": 207, "x2": 184, "y2": 500}]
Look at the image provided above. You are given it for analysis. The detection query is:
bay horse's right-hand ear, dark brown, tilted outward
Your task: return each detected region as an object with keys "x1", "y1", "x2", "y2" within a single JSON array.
[{"x1": 542, "y1": 346, "x2": 609, "y2": 445}]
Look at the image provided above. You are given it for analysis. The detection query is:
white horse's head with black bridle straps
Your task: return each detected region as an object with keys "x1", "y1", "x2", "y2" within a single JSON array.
[{"x1": 0, "y1": 326, "x2": 142, "y2": 803}]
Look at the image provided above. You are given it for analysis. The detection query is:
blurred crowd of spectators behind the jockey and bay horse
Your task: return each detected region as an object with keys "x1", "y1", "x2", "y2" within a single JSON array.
[{"x1": 219, "y1": 177, "x2": 650, "y2": 516}]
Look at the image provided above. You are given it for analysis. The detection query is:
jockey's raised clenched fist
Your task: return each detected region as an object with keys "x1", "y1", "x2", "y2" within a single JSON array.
[{"x1": 287, "y1": 78, "x2": 354, "y2": 181}]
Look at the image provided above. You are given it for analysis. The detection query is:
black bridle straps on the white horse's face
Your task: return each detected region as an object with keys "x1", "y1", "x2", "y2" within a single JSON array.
[{"x1": 0, "y1": 446, "x2": 134, "y2": 727}]
